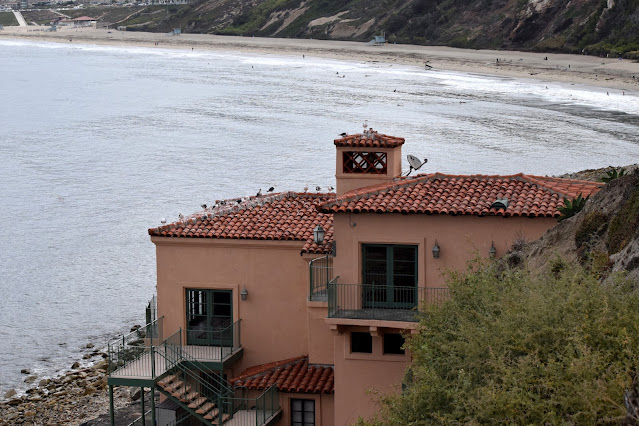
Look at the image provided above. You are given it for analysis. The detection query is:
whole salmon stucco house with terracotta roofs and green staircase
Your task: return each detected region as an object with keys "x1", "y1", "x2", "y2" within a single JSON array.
[{"x1": 109, "y1": 129, "x2": 601, "y2": 425}]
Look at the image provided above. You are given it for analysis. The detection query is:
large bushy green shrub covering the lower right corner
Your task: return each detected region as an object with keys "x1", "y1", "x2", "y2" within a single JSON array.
[{"x1": 362, "y1": 261, "x2": 639, "y2": 425}]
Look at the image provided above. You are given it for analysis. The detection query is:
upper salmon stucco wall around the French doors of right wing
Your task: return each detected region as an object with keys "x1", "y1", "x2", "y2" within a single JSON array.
[{"x1": 333, "y1": 213, "x2": 556, "y2": 287}]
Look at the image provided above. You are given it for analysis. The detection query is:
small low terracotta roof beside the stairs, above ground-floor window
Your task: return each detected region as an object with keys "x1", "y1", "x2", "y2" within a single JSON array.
[{"x1": 231, "y1": 355, "x2": 334, "y2": 393}]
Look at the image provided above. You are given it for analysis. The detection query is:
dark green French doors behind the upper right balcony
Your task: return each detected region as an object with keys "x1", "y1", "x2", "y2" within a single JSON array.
[{"x1": 362, "y1": 244, "x2": 417, "y2": 309}]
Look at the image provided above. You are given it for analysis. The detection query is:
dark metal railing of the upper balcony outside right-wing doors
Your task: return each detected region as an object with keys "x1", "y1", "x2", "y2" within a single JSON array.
[{"x1": 328, "y1": 282, "x2": 449, "y2": 321}]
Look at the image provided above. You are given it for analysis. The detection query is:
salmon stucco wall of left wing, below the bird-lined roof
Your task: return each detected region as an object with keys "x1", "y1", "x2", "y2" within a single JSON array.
[{"x1": 153, "y1": 238, "x2": 316, "y2": 375}]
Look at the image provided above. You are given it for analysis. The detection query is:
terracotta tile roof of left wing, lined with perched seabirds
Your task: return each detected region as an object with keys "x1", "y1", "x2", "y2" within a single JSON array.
[{"x1": 149, "y1": 192, "x2": 335, "y2": 253}]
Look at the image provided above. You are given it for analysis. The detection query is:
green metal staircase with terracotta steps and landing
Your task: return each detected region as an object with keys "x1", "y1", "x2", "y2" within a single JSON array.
[{"x1": 108, "y1": 318, "x2": 281, "y2": 426}]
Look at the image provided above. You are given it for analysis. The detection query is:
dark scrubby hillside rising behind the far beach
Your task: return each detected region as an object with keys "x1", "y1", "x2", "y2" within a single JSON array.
[{"x1": 95, "y1": 0, "x2": 639, "y2": 58}]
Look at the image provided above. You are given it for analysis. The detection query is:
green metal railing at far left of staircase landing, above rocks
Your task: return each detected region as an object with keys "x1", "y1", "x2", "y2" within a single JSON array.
[{"x1": 107, "y1": 317, "x2": 164, "y2": 377}]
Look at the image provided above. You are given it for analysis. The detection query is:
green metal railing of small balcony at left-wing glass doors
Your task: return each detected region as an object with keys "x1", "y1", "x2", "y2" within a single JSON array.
[{"x1": 186, "y1": 320, "x2": 242, "y2": 361}]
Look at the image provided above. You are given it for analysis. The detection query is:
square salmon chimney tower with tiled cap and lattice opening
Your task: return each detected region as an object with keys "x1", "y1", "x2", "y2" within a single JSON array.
[{"x1": 335, "y1": 128, "x2": 404, "y2": 197}]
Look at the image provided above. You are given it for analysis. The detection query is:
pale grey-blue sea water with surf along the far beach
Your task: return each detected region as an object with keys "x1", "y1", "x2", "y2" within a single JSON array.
[{"x1": 0, "y1": 40, "x2": 639, "y2": 397}]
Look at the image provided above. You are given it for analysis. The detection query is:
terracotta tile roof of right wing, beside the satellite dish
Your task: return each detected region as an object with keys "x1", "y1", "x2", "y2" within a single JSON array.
[{"x1": 318, "y1": 173, "x2": 604, "y2": 217}]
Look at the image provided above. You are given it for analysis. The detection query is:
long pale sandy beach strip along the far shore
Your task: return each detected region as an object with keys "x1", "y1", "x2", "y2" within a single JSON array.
[{"x1": 0, "y1": 27, "x2": 639, "y2": 91}]
